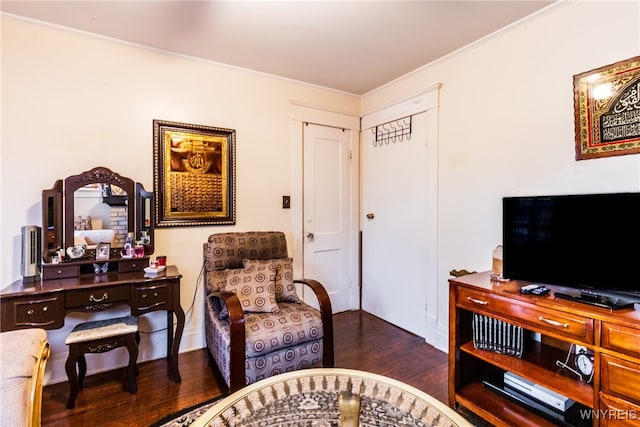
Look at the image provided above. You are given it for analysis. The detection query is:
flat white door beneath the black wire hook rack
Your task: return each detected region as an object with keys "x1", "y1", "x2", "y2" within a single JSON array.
[{"x1": 361, "y1": 108, "x2": 437, "y2": 337}]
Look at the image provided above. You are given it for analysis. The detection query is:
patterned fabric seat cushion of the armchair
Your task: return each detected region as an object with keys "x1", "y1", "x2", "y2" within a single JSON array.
[{"x1": 208, "y1": 296, "x2": 323, "y2": 358}]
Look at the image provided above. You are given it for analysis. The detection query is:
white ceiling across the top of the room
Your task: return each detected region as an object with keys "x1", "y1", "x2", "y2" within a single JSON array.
[{"x1": 0, "y1": 0, "x2": 554, "y2": 95}]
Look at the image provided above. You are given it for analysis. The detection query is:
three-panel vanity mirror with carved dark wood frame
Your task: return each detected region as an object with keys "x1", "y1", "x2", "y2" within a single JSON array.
[{"x1": 42, "y1": 166, "x2": 154, "y2": 270}]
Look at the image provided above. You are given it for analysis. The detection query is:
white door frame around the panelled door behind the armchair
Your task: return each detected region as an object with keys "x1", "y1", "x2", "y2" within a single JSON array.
[{"x1": 289, "y1": 101, "x2": 360, "y2": 309}]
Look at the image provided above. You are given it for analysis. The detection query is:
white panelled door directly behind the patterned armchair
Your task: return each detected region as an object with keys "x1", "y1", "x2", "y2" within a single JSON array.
[{"x1": 302, "y1": 124, "x2": 357, "y2": 313}]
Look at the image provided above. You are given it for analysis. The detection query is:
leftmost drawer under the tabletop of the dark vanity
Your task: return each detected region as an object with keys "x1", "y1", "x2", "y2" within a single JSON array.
[{"x1": 2, "y1": 293, "x2": 64, "y2": 331}]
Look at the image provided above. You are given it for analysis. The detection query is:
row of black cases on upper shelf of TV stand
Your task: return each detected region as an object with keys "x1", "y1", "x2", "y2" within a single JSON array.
[{"x1": 473, "y1": 313, "x2": 525, "y2": 357}]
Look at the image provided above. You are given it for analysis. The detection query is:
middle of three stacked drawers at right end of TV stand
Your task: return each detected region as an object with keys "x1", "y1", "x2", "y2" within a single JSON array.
[{"x1": 600, "y1": 354, "x2": 640, "y2": 404}]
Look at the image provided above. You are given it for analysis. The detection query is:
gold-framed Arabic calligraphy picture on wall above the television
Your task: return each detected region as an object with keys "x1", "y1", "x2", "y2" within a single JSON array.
[{"x1": 573, "y1": 56, "x2": 640, "y2": 160}]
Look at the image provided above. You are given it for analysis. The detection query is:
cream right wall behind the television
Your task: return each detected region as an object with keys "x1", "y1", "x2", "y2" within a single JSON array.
[{"x1": 363, "y1": 1, "x2": 640, "y2": 349}]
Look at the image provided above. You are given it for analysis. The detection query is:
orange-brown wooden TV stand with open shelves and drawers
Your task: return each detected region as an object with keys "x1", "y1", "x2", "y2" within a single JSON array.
[{"x1": 449, "y1": 272, "x2": 640, "y2": 427}]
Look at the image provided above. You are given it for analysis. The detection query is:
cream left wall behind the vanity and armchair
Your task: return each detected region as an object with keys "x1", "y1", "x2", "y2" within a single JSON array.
[{"x1": 0, "y1": 15, "x2": 360, "y2": 383}]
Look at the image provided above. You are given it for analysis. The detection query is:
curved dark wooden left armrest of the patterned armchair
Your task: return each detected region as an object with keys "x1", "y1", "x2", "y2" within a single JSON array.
[{"x1": 211, "y1": 290, "x2": 246, "y2": 392}]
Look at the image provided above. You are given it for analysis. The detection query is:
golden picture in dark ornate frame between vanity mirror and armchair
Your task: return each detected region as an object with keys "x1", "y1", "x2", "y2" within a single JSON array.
[{"x1": 153, "y1": 120, "x2": 236, "y2": 227}]
